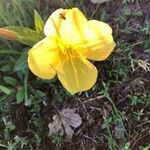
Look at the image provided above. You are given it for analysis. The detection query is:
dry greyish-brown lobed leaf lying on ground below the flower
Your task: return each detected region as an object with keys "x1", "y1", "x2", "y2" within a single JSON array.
[{"x1": 48, "y1": 108, "x2": 82, "y2": 140}]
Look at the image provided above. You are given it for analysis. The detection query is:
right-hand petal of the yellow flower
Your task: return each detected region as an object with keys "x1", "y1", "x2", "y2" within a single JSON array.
[{"x1": 79, "y1": 20, "x2": 116, "y2": 61}]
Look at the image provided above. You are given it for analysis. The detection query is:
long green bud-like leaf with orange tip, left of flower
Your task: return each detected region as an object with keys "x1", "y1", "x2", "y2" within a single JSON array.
[{"x1": 0, "y1": 26, "x2": 43, "y2": 46}]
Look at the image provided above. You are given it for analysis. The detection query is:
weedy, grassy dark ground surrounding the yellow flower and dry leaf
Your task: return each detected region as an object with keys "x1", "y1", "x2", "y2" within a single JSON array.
[{"x1": 0, "y1": 0, "x2": 150, "y2": 150}]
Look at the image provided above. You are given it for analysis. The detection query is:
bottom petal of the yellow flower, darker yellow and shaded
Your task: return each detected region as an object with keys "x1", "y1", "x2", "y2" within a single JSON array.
[{"x1": 57, "y1": 57, "x2": 97, "y2": 94}]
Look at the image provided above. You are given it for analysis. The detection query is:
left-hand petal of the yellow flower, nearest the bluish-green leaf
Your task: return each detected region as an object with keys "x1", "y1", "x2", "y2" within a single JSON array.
[{"x1": 28, "y1": 37, "x2": 59, "y2": 79}]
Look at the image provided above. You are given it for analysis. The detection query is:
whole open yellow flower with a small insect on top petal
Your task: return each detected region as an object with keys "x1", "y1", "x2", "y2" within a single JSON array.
[{"x1": 28, "y1": 8, "x2": 115, "y2": 94}]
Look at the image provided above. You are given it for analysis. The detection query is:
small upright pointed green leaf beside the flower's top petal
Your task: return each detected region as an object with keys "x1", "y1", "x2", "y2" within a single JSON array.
[{"x1": 34, "y1": 10, "x2": 44, "y2": 35}]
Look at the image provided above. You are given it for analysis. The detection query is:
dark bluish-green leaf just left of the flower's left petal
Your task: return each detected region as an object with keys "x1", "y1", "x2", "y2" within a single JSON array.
[{"x1": 13, "y1": 50, "x2": 28, "y2": 71}]
